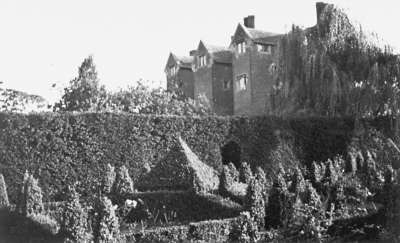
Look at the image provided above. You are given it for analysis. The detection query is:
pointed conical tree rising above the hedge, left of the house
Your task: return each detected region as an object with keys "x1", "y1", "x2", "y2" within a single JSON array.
[{"x1": 54, "y1": 56, "x2": 107, "y2": 111}]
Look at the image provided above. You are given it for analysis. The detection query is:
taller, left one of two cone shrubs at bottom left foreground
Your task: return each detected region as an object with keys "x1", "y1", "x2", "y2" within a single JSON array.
[{"x1": 61, "y1": 186, "x2": 87, "y2": 242}]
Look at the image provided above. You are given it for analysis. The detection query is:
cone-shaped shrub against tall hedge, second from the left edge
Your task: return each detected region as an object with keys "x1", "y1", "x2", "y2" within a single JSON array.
[{"x1": 18, "y1": 172, "x2": 43, "y2": 216}]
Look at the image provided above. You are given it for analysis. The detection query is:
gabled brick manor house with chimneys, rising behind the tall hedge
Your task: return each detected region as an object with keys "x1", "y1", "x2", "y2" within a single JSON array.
[{"x1": 165, "y1": 3, "x2": 325, "y2": 116}]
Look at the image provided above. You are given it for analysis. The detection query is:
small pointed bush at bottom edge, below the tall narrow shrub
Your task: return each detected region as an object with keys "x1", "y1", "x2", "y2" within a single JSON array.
[{"x1": 229, "y1": 211, "x2": 260, "y2": 242}]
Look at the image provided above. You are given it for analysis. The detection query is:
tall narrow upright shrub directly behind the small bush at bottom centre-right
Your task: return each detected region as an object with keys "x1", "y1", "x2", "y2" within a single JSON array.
[{"x1": 246, "y1": 178, "x2": 265, "y2": 228}]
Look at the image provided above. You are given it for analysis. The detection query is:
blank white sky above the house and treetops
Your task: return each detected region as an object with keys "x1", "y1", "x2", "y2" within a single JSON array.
[{"x1": 0, "y1": 0, "x2": 400, "y2": 101}]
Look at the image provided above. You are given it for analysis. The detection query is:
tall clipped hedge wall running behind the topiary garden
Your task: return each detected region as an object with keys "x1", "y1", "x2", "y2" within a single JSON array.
[{"x1": 0, "y1": 113, "x2": 360, "y2": 202}]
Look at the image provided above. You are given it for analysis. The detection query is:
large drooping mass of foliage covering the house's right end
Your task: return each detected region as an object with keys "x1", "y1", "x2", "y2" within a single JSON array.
[{"x1": 271, "y1": 4, "x2": 400, "y2": 117}]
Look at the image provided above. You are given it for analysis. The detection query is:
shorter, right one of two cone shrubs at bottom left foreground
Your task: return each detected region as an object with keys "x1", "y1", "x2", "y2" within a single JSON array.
[{"x1": 93, "y1": 196, "x2": 121, "y2": 243}]
